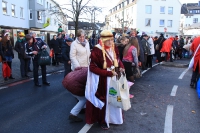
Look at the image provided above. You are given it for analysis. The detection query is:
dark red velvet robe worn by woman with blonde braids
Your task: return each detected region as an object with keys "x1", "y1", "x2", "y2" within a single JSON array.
[{"x1": 86, "y1": 47, "x2": 124, "y2": 124}]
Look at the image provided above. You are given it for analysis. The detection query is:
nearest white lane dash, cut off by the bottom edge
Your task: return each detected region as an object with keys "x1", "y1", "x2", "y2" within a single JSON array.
[{"x1": 164, "y1": 105, "x2": 174, "y2": 133}]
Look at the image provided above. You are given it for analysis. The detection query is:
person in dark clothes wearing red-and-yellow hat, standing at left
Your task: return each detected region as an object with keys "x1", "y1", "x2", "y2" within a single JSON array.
[{"x1": 15, "y1": 32, "x2": 30, "y2": 78}]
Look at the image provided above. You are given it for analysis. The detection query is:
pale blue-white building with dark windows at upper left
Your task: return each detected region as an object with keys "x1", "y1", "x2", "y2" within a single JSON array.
[{"x1": 0, "y1": 0, "x2": 67, "y2": 45}]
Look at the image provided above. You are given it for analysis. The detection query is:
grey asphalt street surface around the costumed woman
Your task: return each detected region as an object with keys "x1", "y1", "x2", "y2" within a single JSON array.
[{"x1": 0, "y1": 61, "x2": 200, "y2": 133}]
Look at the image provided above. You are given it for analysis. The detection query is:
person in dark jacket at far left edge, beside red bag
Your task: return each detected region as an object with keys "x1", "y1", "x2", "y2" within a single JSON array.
[{"x1": 2, "y1": 32, "x2": 15, "y2": 81}]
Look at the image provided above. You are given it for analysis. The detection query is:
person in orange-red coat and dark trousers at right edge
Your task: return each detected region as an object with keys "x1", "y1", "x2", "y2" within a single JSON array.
[{"x1": 190, "y1": 36, "x2": 200, "y2": 87}]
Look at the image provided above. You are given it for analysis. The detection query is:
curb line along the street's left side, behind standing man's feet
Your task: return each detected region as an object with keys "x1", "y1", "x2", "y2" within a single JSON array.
[{"x1": 0, "y1": 69, "x2": 64, "y2": 87}]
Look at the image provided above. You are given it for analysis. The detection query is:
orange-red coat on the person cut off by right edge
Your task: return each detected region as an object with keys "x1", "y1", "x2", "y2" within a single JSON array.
[{"x1": 191, "y1": 37, "x2": 200, "y2": 74}]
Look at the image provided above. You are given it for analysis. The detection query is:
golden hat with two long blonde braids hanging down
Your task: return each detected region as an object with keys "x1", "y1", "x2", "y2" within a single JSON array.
[{"x1": 100, "y1": 30, "x2": 118, "y2": 69}]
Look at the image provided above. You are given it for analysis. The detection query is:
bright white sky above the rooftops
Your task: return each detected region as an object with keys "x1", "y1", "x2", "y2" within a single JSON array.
[{"x1": 56, "y1": 0, "x2": 199, "y2": 22}]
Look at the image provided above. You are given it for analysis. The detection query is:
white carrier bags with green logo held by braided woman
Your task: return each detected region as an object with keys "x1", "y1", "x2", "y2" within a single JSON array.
[{"x1": 108, "y1": 75, "x2": 131, "y2": 111}]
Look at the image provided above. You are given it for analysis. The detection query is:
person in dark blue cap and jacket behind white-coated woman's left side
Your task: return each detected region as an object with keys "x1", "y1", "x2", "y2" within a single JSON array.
[{"x1": 62, "y1": 38, "x2": 74, "y2": 77}]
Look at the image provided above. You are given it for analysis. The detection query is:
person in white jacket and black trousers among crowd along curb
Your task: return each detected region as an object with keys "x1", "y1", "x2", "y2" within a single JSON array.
[{"x1": 146, "y1": 37, "x2": 155, "y2": 68}]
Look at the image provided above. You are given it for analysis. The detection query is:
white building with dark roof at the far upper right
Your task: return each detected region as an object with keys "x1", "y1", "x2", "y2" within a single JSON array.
[{"x1": 180, "y1": 1, "x2": 200, "y2": 36}]
